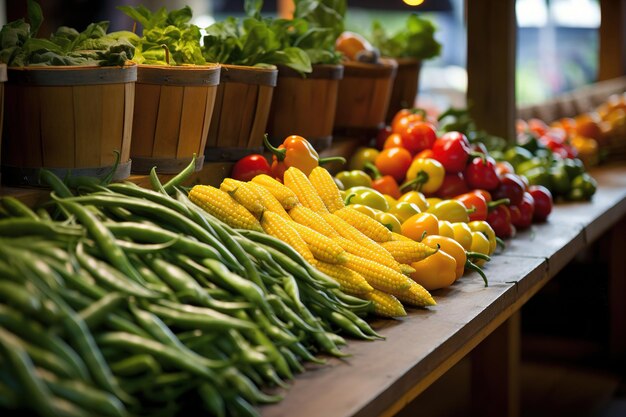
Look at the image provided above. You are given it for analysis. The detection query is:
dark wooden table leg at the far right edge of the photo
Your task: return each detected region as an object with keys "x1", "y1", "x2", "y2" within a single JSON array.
[{"x1": 608, "y1": 217, "x2": 626, "y2": 365}]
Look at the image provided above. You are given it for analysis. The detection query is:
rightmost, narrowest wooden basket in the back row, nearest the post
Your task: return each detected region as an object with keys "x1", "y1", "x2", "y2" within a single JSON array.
[{"x1": 386, "y1": 58, "x2": 422, "y2": 123}]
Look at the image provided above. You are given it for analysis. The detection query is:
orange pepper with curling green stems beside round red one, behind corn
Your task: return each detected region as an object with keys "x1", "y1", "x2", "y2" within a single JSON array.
[{"x1": 263, "y1": 135, "x2": 346, "y2": 180}]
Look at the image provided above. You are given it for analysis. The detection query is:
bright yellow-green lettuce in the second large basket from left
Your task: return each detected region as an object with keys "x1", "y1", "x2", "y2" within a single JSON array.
[{"x1": 118, "y1": 6, "x2": 206, "y2": 65}]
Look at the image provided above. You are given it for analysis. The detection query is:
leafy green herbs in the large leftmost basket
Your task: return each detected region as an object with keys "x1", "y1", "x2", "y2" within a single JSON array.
[{"x1": 0, "y1": 0, "x2": 135, "y2": 67}]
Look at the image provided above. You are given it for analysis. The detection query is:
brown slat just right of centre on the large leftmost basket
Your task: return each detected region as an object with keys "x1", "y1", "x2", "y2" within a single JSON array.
[{"x1": 72, "y1": 85, "x2": 101, "y2": 167}]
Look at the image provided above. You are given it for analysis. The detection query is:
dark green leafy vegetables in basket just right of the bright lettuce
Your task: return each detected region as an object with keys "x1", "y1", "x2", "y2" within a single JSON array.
[{"x1": 202, "y1": 0, "x2": 312, "y2": 73}]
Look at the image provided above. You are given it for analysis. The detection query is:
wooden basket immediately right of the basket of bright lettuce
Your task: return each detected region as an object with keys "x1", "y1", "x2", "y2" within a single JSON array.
[{"x1": 204, "y1": 65, "x2": 278, "y2": 161}]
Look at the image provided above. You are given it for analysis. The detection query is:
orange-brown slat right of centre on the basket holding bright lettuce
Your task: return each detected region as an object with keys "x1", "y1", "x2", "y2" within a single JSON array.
[{"x1": 176, "y1": 86, "x2": 207, "y2": 158}]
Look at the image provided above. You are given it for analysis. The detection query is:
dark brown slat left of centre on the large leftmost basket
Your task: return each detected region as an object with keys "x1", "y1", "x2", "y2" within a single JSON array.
[{"x1": 40, "y1": 87, "x2": 75, "y2": 168}]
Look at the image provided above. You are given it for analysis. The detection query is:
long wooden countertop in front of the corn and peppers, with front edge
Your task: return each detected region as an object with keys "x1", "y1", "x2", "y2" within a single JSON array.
[{"x1": 261, "y1": 165, "x2": 626, "y2": 417}]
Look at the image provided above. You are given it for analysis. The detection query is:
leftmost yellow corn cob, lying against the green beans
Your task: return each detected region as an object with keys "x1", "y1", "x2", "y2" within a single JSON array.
[{"x1": 189, "y1": 185, "x2": 263, "y2": 232}]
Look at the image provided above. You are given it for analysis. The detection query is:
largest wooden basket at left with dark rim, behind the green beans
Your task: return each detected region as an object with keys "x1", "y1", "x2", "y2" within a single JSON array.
[{"x1": 2, "y1": 64, "x2": 137, "y2": 185}]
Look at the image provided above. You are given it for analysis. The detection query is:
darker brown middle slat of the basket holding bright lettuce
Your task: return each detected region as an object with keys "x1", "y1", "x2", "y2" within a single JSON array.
[{"x1": 152, "y1": 85, "x2": 183, "y2": 158}]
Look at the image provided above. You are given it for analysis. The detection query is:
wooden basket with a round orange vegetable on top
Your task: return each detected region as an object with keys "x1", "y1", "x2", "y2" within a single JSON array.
[{"x1": 335, "y1": 58, "x2": 398, "y2": 131}]
